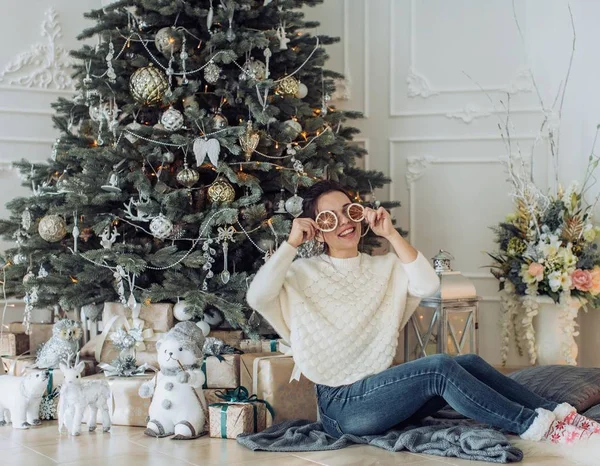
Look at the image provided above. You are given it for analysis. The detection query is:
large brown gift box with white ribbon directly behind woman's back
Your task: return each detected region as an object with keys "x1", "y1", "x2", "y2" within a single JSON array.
[{"x1": 240, "y1": 353, "x2": 317, "y2": 424}]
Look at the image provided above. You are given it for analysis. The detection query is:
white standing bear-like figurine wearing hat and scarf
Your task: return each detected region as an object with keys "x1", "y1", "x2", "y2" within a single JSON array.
[{"x1": 139, "y1": 321, "x2": 206, "y2": 440}]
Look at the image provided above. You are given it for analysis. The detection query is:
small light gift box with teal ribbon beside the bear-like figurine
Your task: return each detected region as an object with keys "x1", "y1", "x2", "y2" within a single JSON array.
[{"x1": 208, "y1": 403, "x2": 267, "y2": 439}]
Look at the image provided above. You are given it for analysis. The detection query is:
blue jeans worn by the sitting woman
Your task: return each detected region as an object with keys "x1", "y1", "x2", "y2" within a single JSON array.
[{"x1": 316, "y1": 354, "x2": 557, "y2": 438}]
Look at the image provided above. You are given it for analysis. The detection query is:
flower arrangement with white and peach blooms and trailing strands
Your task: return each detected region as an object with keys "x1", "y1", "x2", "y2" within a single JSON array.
[{"x1": 488, "y1": 156, "x2": 600, "y2": 364}]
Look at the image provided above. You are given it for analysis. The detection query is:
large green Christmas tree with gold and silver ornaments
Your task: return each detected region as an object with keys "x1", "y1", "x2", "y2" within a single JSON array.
[{"x1": 0, "y1": 0, "x2": 397, "y2": 335}]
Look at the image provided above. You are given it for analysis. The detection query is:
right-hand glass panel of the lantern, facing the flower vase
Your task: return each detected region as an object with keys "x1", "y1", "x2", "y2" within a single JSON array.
[{"x1": 446, "y1": 306, "x2": 477, "y2": 356}]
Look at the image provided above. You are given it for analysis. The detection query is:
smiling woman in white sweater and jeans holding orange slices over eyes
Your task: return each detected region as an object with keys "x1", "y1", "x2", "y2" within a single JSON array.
[{"x1": 247, "y1": 181, "x2": 600, "y2": 444}]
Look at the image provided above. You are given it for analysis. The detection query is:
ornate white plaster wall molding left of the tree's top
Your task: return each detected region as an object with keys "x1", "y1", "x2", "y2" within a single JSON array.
[{"x1": 0, "y1": 8, "x2": 74, "y2": 90}]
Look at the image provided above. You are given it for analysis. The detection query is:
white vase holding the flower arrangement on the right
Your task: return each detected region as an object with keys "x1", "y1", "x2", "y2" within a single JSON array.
[{"x1": 533, "y1": 296, "x2": 581, "y2": 366}]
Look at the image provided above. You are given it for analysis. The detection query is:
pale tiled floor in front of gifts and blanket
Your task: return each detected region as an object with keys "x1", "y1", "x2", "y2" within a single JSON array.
[{"x1": 0, "y1": 422, "x2": 572, "y2": 466}]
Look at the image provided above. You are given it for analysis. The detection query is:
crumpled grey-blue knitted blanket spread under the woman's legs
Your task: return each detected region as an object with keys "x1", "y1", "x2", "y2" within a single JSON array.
[{"x1": 237, "y1": 418, "x2": 523, "y2": 463}]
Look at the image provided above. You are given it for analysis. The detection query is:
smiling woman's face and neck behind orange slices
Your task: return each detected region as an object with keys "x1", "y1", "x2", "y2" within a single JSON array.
[{"x1": 315, "y1": 191, "x2": 361, "y2": 257}]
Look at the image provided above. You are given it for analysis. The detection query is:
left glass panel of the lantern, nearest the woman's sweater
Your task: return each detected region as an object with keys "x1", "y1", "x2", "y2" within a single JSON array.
[{"x1": 404, "y1": 305, "x2": 441, "y2": 361}]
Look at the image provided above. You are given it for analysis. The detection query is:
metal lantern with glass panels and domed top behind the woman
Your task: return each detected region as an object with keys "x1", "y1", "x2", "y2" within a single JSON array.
[{"x1": 404, "y1": 250, "x2": 480, "y2": 361}]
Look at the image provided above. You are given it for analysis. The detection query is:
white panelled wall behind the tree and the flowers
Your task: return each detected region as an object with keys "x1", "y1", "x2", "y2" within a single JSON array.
[{"x1": 0, "y1": 0, "x2": 600, "y2": 365}]
